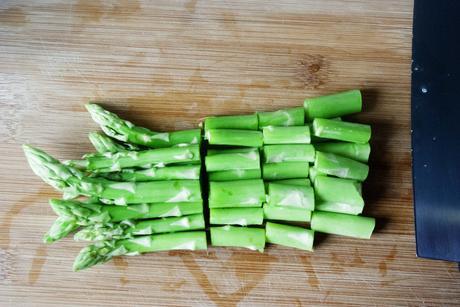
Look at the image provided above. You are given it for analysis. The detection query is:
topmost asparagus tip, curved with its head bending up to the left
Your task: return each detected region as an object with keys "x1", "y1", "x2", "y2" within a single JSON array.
[{"x1": 86, "y1": 103, "x2": 201, "y2": 148}]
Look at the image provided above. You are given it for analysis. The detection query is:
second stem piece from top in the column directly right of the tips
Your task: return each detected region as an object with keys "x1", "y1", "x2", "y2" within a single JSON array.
[{"x1": 205, "y1": 129, "x2": 263, "y2": 147}]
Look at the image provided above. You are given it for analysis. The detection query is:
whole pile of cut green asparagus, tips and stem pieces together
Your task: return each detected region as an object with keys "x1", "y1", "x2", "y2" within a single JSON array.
[{"x1": 23, "y1": 90, "x2": 375, "y2": 271}]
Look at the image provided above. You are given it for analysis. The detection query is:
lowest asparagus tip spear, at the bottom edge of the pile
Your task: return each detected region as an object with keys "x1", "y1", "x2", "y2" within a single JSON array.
[{"x1": 73, "y1": 231, "x2": 207, "y2": 271}]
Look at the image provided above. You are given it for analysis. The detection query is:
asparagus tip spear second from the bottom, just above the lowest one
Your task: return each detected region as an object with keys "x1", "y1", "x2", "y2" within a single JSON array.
[{"x1": 74, "y1": 214, "x2": 205, "y2": 241}]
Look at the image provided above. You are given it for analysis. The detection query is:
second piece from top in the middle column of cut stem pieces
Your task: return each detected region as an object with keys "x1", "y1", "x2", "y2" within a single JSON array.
[{"x1": 263, "y1": 126, "x2": 310, "y2": 144}]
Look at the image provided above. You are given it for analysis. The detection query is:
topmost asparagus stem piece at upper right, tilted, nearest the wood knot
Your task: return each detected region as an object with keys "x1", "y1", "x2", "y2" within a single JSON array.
[{"x1": 304, "y1": 90, "x2": 362, "y2": 120}]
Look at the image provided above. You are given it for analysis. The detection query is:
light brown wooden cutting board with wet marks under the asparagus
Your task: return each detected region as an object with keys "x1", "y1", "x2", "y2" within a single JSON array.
[{"x1": 0, "y1": 0, "x2": 460, "y2": 306}]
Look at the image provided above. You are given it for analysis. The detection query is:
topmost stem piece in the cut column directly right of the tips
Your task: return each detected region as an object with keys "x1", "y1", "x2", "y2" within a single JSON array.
[{"x1": 204, "y1": 114, "x2": 259, "y2": 130}]
